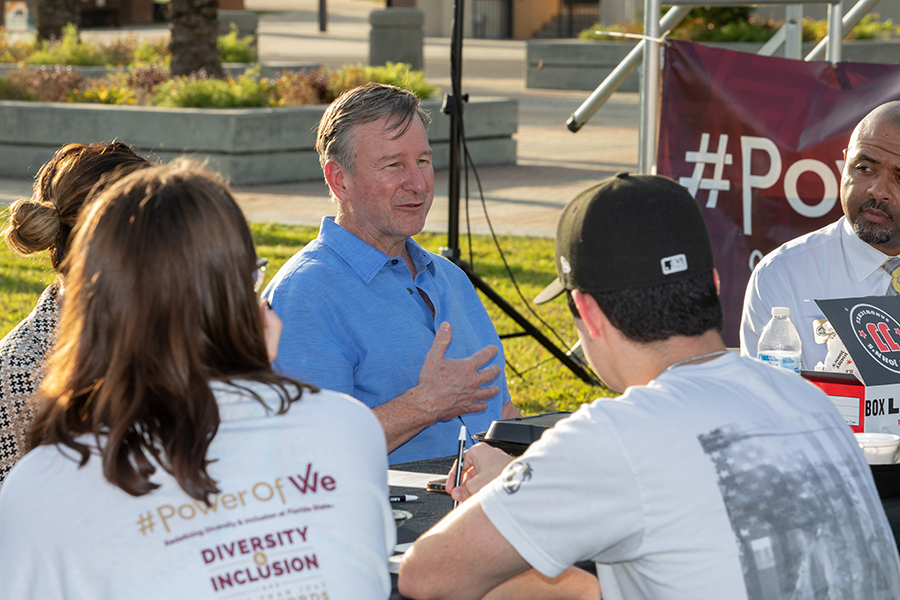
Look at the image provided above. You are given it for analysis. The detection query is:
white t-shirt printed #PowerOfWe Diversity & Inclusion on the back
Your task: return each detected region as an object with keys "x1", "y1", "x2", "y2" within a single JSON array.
[{"x1": 0, "y1": 384, "x2": 396, "y2": 600}]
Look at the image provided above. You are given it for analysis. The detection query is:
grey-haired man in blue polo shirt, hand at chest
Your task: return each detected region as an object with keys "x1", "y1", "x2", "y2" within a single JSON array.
[{"x1": 265, "y1": 84, "x2": 519, "y2": 464}]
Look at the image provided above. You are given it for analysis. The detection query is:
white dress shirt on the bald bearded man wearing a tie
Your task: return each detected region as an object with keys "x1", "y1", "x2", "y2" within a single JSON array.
[{"x1": 741, "y1": 217, "x2": 891, "y2": 370}]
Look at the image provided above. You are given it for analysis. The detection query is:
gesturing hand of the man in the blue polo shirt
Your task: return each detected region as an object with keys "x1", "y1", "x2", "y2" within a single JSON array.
[{"x1": 417, "y1": 322, "x2": 500, "y2": 421}]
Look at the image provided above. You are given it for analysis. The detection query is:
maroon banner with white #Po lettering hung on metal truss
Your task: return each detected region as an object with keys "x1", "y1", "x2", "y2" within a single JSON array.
[{"x1": 657, "y1": 41, "x2": 900, "y2": 346}]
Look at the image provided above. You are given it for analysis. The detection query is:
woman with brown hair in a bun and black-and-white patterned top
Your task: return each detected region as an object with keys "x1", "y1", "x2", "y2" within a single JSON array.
[{"x1": 0, "y1": 142, "x2": 150, "y2": 484}]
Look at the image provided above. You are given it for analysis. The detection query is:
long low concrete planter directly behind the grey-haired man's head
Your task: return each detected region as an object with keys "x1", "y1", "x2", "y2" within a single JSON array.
[{"x1": 0, "y1": 99, "x2": 518, "y2": 185}]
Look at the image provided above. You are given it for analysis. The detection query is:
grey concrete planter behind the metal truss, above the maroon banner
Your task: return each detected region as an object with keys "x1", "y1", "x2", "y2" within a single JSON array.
[{"x1": 525, "y1": 40, "x2": 900, "y2": 92}]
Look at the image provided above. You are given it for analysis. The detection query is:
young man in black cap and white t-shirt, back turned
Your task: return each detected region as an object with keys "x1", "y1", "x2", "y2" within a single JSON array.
[{"x1": 400, "y1": 173, "x2": 900, "y2": 600}]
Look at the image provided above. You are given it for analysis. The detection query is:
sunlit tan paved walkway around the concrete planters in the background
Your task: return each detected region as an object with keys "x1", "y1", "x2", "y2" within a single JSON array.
[{"x1": 0, "y1": 0, "x2": 638, "y2": 237}]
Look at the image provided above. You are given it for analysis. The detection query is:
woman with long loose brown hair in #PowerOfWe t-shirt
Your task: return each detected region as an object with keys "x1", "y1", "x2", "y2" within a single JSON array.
[{"x1": 0, "y1": 162, "x2": 395, "y2": 600}]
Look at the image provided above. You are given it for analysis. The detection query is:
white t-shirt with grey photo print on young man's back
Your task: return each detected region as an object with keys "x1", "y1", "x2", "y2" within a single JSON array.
[{"x1": 475, "y1": 354, "x2": 900, "y2": 600}]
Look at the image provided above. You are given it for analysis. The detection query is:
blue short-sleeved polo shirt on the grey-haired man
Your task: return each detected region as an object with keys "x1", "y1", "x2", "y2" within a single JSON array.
[{"x1": 264, "y1": 217, "x2": 509, "y2": 464}]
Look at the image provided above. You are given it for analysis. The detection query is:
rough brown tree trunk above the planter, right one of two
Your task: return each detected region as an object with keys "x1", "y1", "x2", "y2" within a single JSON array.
[{"x1": 169, "y1": 0, "x2": 224, "y2": 77}]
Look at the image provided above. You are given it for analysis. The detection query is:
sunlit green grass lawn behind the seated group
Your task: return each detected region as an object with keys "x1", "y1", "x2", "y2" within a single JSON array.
[{"x1": 0, "y1": 209, "x2": 610, "y2": 414}]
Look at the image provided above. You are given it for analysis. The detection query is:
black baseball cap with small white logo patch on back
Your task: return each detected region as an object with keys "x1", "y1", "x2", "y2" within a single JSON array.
[{"x1": 534, "y1": 173, "x2": 713, "y2": 304}]
